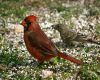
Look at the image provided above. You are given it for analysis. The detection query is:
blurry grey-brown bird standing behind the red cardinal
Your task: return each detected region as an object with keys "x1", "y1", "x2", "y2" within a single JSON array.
[{"x1": 52, "y1": 24, "x2": 100, "y2": 46}]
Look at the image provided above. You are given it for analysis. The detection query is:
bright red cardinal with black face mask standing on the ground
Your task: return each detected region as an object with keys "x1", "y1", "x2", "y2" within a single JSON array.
[{"x1": 21, "y1": 15, "x2": 82, "y2": 64}]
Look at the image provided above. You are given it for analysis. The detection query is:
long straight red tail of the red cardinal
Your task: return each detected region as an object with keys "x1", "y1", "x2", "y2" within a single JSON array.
[{"x1": 58, "y1": 52, "x2": 82, "y2": 65}]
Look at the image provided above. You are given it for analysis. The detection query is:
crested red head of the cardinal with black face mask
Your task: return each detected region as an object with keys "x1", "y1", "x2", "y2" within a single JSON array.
[{"x1": 21, "y1": 15, "x2": 37, "y2": 30}]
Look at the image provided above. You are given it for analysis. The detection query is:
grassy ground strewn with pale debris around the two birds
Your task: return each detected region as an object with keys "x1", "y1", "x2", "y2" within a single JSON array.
[{"x1": 0, "y1": 0, "x2": 100, "y2": 80}]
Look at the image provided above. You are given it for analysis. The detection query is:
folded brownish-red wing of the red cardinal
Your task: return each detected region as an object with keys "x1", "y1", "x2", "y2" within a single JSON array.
[{"x1": 28, "y1": 29, "x2": 58, "y2": 55}]
